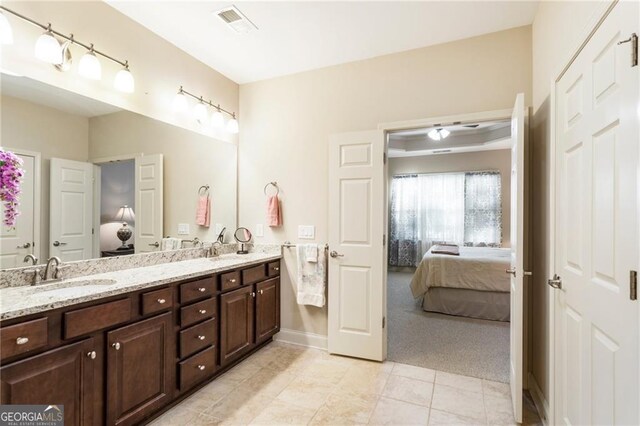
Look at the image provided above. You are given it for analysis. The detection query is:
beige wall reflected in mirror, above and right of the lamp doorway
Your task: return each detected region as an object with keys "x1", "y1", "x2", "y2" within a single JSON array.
[{"x1": 89, "y1": 111, "x2": 237, "y2": 241}]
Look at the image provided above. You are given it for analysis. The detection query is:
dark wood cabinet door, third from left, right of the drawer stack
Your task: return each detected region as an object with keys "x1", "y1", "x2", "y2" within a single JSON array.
[{"x1": 220, "y1": 286, "x2": 255, "y2": 365}]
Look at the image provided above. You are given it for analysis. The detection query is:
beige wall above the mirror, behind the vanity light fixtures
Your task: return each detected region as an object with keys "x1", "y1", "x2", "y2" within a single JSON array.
[{"x1": 1, "y1": 1, "x2": 242, "y2": 141}]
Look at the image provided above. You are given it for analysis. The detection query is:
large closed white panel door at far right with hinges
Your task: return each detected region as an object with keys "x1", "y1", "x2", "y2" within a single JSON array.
[{"x1": 550, "y1": 1, "x2": 640, "y2": 425}]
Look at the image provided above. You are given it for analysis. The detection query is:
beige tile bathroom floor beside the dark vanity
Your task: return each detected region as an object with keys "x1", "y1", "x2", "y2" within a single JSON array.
[{"x1": 152, "y1": 342, "x2": 540, "y2": 426}]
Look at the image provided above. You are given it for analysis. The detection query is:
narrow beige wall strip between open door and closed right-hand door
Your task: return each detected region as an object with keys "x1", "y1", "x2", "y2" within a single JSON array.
[{"x1": 531, "y1": 1, "x2": 609, "y2": 410}]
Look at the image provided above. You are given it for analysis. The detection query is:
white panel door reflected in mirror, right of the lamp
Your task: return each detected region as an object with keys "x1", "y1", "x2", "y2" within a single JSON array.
[{"x1": 134, "y1": 154, "x2": 163, "y2": 253}]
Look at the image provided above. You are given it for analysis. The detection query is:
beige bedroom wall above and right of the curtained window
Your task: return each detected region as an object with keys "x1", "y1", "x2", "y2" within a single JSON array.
[{"x1": 389, "y1": 149, "x2": 511, "y2": 247}]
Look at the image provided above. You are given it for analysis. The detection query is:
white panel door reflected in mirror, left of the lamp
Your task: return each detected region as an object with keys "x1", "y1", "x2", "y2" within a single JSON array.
[{"x1": 49, "y1": 158, "x2": 93, "y2": 262}]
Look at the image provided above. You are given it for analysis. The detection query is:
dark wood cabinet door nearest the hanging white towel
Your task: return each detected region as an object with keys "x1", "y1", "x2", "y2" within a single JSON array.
[{"x1": 256, "y1": 278, "x2": 280, "y2": 343}]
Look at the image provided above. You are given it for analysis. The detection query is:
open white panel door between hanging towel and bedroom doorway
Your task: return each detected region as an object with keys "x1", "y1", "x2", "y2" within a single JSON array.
[{"x1": 328, "y1": 130, "x2": 386, "y2": 361}]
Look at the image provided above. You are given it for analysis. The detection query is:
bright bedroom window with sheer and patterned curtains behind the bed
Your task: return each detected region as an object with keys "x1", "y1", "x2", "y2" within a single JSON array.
[{"x1": 389, "y1": 172, "x2": 502, "y2": 266}]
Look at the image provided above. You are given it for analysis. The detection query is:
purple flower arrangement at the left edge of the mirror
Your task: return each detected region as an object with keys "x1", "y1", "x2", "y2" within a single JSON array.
[{"x1": 0, "y1": 148, "x2": 24, "y2": 227}]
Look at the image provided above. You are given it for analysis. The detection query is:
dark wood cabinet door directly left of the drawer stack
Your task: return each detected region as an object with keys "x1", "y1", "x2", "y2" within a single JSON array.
[{"x1": 107, "y1": 312, "x2": 175, "y2": 425}]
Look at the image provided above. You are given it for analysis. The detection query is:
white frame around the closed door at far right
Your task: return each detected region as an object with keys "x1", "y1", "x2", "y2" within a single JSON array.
[{"x1": 534, "y1": 0, "x2": 620, "y2": 425}]
